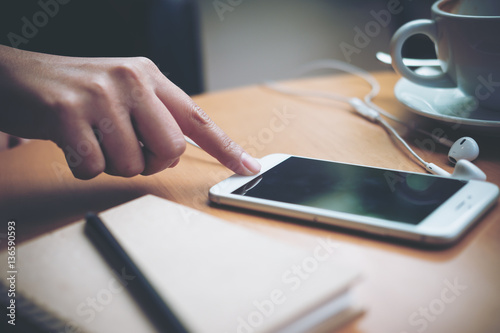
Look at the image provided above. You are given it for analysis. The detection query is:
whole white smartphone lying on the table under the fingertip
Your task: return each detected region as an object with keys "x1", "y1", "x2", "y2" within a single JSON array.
[{"x1": 209, "y1": 154, "x2": 499, "y2": 244}]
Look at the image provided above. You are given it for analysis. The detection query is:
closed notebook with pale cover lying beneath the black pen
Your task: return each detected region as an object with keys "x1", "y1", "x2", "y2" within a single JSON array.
[{"x1": 0, "y1": 195, "x2": 360, "y2": 333}]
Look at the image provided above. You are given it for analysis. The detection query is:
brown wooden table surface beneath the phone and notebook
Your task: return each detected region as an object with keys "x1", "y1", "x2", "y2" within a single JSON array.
[{"x1": 0, "y1": 72, "x2": 500, "y2": 333}]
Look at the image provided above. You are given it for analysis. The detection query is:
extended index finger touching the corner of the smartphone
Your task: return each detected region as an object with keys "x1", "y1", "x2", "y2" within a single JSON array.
[{"x1": 156, "y1": 78, "x2": 261, "y2": 176}]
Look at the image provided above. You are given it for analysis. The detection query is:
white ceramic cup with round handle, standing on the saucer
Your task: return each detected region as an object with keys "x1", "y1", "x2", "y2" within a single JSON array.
[{"x1": 391, "y1": 0, "x2": 500, "y2": 111}]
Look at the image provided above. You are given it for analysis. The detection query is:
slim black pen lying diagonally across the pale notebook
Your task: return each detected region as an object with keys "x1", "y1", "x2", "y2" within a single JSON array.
[{"x1": 86, "y1": 213, "x2": 188, "y2": 333}]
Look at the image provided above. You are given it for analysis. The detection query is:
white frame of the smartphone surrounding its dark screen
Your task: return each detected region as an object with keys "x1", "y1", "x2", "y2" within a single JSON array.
[{"x1": 209, "y1": 154, "x2": 499, "y2": 244}]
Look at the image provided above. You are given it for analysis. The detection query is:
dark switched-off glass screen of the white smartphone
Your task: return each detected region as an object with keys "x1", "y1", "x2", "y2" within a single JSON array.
[{"x1": 232, "y1": 156, "x2": 467, "y2": 225}]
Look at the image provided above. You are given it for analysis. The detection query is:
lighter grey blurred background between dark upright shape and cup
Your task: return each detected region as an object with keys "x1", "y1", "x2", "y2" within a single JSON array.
[{"x1": 198, "y1": 0, "x2": 433, "y2": 90}]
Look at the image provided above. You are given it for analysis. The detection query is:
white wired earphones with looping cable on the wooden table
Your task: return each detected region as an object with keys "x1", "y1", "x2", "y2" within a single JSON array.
[{"x1": 266, "y1": 60, "x2": 486, "y2": 181}]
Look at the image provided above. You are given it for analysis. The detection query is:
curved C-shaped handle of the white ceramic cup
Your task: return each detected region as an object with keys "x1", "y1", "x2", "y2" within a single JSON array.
[{"x1": 391, "y1": 19, "x2": 457, "y2": 88}]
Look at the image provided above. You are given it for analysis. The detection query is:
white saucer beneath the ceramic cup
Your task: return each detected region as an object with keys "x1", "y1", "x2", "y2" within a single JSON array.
[{"x1": 394, "y1": 67, "x2": 500, "y2": 130}]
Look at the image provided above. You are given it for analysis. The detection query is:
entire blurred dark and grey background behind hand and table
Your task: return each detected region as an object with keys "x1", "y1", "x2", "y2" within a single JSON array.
[{"x1": 0, "y1": 0, "x2": 434, "y2": 95}]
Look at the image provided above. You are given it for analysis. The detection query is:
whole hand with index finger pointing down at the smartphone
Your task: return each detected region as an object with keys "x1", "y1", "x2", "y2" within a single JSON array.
[{"x1": 0, "y1": 46, "x2": 260, "y2": 179}]
